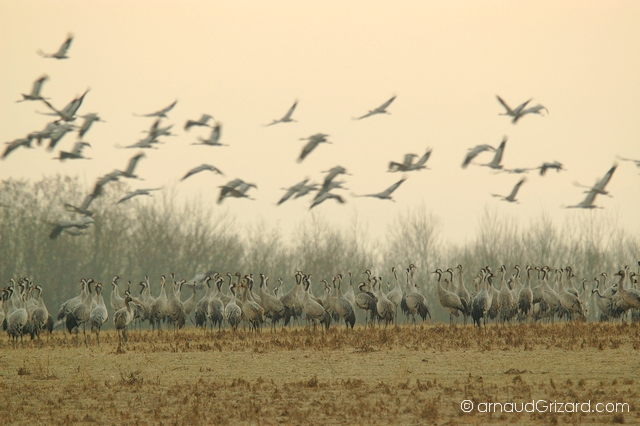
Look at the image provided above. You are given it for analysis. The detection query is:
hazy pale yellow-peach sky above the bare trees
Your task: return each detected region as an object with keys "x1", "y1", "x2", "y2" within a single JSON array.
[{"x1": 0, "y1": 0, "x2": 640, "y2": 242}]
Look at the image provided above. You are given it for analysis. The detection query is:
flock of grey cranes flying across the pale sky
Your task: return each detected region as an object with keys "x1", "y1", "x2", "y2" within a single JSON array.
[{"x1": 2, "y1": 35, "x2": 640, "y2": 239}]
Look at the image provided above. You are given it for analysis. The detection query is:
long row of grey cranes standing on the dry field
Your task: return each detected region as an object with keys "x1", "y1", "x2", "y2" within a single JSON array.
[{"x1": 5, "y1": 262, "x2": 640, "y2": 347}]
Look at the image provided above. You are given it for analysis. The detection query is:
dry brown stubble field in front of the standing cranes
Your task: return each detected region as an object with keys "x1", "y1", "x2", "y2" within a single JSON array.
[{"x1": 0, "y1": 323, "x2": 640, "y2": 425}]
